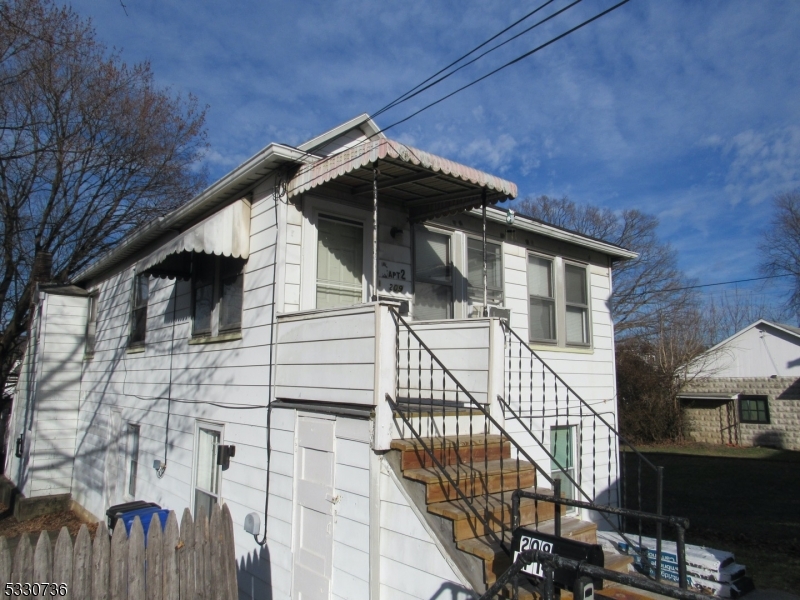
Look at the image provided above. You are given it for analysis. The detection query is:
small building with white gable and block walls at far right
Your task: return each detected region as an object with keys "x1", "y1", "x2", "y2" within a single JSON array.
[{"x1": 678, "y1": 319, "x2": 800, "y2": 450}]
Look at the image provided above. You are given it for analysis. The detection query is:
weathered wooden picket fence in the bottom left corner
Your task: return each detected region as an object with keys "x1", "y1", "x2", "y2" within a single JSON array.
[{"x1": 0, "y1": 506, "x2": 238, "y2": 600}]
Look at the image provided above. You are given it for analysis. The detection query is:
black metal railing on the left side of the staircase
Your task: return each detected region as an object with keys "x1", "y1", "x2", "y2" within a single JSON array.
[{"x1": 386, "y1": 307, "x2": 560, "y2": 555}]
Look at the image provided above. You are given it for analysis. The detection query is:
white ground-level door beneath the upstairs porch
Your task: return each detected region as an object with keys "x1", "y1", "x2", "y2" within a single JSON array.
[{"x1": 292, "y1": 416, "x2": 336, "y2": 600}]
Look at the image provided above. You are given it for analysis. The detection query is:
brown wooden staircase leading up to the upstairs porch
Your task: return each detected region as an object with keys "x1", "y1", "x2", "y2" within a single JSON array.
[{"x1": 392, "y1": 433, "x2": 632, "y2": 598}]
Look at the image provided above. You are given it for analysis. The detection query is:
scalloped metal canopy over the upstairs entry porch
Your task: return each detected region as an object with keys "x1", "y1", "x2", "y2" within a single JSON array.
[{"x1": 287, "y1": 139, "x2": 517, "y2": 222}]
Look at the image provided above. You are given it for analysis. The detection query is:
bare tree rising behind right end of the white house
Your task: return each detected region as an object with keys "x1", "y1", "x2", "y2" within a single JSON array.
[{"x1": 517, "y1": 196, "x2": 693, "y2": 338}]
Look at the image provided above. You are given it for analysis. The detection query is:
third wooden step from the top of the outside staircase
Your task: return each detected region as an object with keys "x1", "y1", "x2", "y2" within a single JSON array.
[{"x1": 428, "y1": 488, "x2": 567, "y2": 542}]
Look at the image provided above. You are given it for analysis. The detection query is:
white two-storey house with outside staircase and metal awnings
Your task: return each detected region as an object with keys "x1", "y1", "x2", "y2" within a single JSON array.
[{"x1": 6, "y1": 115, "x2": 636, "y2": 598}]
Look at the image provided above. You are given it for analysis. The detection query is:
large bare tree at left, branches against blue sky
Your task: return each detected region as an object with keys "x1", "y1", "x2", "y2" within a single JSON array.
[{"x1": 0, "y1": 0, "x2": 205, "y2": 398}]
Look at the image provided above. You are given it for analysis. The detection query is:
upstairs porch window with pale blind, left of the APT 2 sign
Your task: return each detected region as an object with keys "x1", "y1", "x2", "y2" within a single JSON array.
[{"x1": 316, "y1": 215, "x2": 364, "y2": 308}]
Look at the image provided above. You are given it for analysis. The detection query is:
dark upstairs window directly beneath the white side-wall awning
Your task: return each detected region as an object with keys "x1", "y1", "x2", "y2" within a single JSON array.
[{"x1": 192, "y1": 253, "x2": 244, "y2": 336}]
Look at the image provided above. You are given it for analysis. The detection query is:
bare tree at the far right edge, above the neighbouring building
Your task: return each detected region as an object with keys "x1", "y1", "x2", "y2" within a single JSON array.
[{"x1": 759, "y1": 190, "x2": 800, "y2": 315}]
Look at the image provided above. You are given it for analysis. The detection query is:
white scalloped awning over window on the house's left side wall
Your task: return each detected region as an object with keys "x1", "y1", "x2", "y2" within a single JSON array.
[{"x1": 136, "y1": 198, "x2": 250, "y2": 279}]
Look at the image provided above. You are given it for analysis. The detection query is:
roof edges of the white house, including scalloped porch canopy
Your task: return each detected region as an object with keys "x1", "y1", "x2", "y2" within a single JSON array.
[{"x1": 72, "y1": 114, "x2": 637, "y2": 284}]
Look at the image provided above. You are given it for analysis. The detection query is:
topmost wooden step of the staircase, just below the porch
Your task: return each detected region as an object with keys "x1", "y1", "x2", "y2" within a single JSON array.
[{"x1": 391, "y1": 431, "x2": 511, "y2": 471}]
